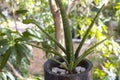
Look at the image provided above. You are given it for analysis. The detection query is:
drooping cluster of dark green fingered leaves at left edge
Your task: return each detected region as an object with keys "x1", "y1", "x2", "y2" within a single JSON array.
[{"x1": 0, "y1": 28, "x2": 32, "y2": 70}]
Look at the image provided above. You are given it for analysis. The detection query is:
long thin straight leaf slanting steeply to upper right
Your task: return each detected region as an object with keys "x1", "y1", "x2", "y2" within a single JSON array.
[{"x1": 75, "y1": 5, "x2": 104, "y2": 58}]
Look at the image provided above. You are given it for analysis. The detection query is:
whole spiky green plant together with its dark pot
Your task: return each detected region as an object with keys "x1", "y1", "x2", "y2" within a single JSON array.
[{"x1": 23, "y1": 0, "x2": 107, "y2": 80}]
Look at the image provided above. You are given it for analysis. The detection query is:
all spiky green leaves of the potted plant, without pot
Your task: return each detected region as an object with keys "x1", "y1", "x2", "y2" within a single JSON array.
[{"x1": 23, "y1": 1, "x2": 106, "y2": 73}]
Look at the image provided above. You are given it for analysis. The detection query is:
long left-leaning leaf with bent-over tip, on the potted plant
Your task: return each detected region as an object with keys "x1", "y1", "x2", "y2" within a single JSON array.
[{"x1": 23, "y1": 19, "x2": 67, "y2": 54}]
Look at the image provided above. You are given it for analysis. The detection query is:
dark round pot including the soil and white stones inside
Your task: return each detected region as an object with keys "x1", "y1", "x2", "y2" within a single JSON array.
[{"x1": 44, "y1": 58, "x2": 92, "y2": 80}]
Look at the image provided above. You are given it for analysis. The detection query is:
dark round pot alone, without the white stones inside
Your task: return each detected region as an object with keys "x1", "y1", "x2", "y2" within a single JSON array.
[{"x1": 44, "y1": 59, "x2": 92, "y2": 80}]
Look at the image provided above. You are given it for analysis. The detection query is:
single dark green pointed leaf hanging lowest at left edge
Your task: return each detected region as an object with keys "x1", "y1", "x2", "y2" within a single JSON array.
[{"x1": 0, "y1": 47, "x2": 11, "y2": 71}]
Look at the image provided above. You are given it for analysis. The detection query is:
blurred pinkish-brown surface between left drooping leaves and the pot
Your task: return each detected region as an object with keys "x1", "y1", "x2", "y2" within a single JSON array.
[{"x1": 28, "y1": 48, "x2": 46, "y2": 75}]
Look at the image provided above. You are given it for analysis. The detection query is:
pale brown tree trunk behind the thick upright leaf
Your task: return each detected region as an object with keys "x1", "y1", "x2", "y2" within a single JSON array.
[{"x1": 49, "y1": 0, "x2": 64, "y2": 53}]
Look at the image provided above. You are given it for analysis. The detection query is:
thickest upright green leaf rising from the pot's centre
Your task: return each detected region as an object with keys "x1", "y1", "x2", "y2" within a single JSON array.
[{"x1": 57, "y1": 0, "x2": 75, "y2": 72}]
